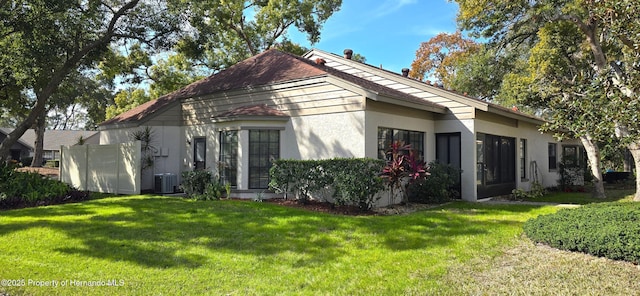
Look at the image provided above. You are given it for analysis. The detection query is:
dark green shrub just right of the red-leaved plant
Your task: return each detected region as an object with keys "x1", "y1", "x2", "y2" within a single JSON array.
[{"x1": 407, "y1": 162, "x2": 460, "y2": 203}]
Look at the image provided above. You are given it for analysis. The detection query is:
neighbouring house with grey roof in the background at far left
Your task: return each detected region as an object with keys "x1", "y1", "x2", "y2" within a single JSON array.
[{"x1": 0, "y1": 128, "x2": 100, "y2": 165}]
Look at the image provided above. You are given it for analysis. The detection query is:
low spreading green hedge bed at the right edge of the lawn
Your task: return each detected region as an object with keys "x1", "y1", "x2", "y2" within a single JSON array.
[{"x1": 524, "y1": 202, "x2": 640, "y2": 264}]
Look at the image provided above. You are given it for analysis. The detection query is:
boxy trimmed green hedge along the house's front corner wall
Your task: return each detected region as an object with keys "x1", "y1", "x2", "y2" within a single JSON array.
[{"x1": 269, "y1": 158, "x2": 385, "y2": 209}]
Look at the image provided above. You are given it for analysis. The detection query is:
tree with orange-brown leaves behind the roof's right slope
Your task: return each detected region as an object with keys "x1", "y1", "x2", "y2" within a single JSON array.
[{"x1": 409, "y1": 32, "x2": 480, "y2": 88}]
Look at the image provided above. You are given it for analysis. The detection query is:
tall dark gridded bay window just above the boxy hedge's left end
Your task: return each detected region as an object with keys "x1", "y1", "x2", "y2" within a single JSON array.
[{"x1": 249, "y1": 130, "x2": 280, "y2": 189}]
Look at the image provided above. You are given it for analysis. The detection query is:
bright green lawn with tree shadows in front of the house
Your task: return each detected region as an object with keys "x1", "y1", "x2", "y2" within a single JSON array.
[{"x1": 0, "y1": 196, "x2": 555, "y2": 295}]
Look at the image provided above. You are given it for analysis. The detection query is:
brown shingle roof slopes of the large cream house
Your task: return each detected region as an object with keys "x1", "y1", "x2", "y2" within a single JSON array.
[{"x1": 101, "y1": 49, "x2": 444, "y2": 125}]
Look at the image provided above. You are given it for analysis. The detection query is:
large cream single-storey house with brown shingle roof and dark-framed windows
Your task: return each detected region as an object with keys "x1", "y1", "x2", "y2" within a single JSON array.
[{"x1": 100, "y1": 49, "x2": 578, "y2": 201}]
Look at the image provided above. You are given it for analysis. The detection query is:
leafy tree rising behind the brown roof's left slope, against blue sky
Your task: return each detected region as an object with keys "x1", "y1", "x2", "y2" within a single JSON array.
[{"x1": 169, "y1": 0, "x2": 342, "y2": 72}]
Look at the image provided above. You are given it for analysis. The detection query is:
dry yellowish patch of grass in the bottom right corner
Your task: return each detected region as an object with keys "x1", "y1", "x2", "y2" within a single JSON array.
[{"x1": 447, "y1": 237, "x2": 640, "y2": 295}]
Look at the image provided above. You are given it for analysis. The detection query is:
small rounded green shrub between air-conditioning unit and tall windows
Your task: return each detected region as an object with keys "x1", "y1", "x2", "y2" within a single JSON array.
[{"x1": 180, "y1": 170, "x2": 225, "y2": 200}]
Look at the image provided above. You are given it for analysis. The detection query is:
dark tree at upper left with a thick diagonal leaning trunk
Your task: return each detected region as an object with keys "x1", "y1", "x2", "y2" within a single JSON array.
[{"x1": 0, "y1": 0, "x2": 178, "y2": 161}]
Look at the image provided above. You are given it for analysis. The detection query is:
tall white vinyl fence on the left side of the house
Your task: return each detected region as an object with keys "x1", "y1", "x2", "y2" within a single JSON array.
[{"x1": 60, "y1": 141, "x2": 141, "y2": 194}]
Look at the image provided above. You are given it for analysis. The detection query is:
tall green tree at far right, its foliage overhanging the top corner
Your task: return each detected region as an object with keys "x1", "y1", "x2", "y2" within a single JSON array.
[{"x1": 456, "y1": 0, "x2": 640, "y2": 201}]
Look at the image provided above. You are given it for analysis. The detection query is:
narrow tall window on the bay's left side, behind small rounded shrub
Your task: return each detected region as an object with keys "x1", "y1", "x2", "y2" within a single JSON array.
[{"x1": 220, "y1": 131, "x2": 238, "y2": 187}]
